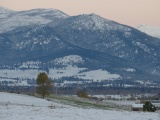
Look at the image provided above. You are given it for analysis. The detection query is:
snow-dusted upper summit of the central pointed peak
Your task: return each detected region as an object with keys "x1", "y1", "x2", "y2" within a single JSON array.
[{"x1": 60, "y1": 14, "x2": 130, "y2": 31}]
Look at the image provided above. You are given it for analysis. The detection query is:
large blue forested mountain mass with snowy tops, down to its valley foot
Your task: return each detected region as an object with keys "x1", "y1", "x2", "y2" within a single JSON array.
[{"x1": 0, "y1": 9, "x2": 160, "y2": 85}]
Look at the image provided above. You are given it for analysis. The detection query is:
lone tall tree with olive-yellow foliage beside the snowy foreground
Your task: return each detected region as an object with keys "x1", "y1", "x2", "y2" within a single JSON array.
[{"x1": 36, "y1": 72, "x2": 53, "y2": 98}]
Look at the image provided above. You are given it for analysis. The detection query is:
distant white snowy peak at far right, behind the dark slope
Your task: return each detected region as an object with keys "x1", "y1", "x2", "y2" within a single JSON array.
[{"x1": 136, "y1": 25, "x2": 160, "y2": 38}]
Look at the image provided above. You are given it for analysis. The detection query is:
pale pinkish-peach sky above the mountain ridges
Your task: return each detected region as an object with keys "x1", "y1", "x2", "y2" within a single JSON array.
[{"x1": 0, "y1": 0, "x2": 160, "y2": 26}]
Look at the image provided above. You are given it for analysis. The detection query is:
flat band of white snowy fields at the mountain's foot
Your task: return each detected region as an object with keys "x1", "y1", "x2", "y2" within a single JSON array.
[{"x1": 0, "y1": 66, "x2": 120, "y2": 81}]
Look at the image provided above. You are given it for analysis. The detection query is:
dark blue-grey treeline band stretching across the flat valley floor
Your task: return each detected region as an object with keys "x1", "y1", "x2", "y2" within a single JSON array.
[{"x1": 0, "y1": 86, "x2": 160, "y2": 95}]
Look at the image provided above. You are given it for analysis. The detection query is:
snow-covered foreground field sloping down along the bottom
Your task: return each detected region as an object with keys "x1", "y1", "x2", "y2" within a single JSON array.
[{"x1": 0, "y1": 92, "x2": 160, "y2": 120}]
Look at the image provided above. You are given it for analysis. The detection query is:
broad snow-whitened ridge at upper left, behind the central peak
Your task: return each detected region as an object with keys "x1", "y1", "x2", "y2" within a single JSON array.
[{"x1": 0, "y1": 8, "x2": 68, "y2": 33}]
